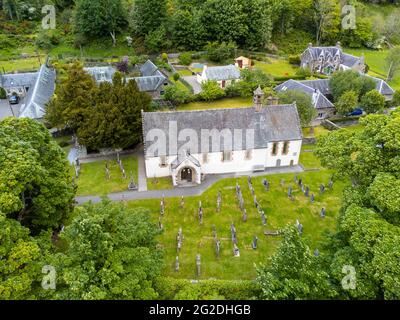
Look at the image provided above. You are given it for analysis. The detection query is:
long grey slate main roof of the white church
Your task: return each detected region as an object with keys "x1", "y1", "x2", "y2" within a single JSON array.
[{"x1": 142, "y1": 104, "x2": 302, "y2": 157}]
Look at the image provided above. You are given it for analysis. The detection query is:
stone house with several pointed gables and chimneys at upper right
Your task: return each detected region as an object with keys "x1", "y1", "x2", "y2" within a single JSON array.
[{"x1": 301, "y1": 42, "x2": 366, "y2": 75}]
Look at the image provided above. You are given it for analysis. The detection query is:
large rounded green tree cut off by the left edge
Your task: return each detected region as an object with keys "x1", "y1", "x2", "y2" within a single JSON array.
[{"x1": 0, "y1": 118, "x2": 75, "y2": 233}]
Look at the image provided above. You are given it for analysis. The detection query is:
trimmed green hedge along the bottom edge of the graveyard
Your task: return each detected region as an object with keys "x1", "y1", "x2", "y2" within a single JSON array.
[{"x1": 155, "y1": 278, "x2": 261, "y2": 300}]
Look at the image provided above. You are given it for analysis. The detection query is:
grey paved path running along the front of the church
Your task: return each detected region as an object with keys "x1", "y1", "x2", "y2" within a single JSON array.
[{"x1": 76, "y1": 166, "x2": 304, "y2": 204}]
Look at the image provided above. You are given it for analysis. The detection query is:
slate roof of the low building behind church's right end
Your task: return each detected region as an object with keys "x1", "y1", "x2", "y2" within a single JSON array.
[{"x1": 275, "y1": 80, "x2": 335, "y2": 109}]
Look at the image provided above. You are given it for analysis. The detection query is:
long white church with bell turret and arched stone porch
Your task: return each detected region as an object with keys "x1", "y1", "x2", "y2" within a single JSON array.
[{"x1": 142, "y1": 89, "x2": 302, "y2": 186}]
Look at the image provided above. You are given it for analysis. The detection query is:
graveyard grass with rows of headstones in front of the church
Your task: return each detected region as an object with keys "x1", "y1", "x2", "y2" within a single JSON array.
[{"x1": 127, "y1": 152, "x2": 345, "y2": 280}]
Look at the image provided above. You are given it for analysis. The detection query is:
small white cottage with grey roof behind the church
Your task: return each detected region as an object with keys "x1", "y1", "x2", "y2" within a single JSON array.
[{"x1": 197, "y1": 65, "x2": 240, "y2": 89}]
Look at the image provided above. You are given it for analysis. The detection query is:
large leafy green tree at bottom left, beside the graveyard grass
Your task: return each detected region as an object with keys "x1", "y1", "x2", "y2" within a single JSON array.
[{"x1": 48, "y1": 200, "x2": 163, "y2": 300}]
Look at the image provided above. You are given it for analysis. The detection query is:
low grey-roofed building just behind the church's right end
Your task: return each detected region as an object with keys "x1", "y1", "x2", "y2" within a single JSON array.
[{"x1": 275, "y1": 79, "x2": 336, "y2": 119}]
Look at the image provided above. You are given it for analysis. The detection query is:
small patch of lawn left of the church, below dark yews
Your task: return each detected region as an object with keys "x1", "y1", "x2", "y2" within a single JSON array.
[{"x1": 76, "y1": 156, "x2": 138, "y2": 196}]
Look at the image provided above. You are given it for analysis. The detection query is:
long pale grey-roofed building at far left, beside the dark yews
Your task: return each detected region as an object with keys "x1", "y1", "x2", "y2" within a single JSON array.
[{"x1": 19, "y1": 64, "x2": 56, "y2": 119}]
